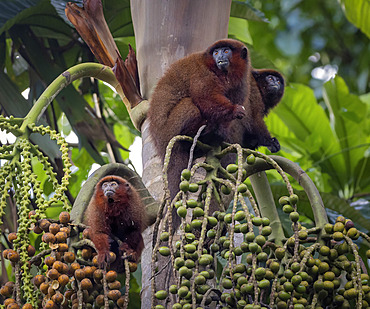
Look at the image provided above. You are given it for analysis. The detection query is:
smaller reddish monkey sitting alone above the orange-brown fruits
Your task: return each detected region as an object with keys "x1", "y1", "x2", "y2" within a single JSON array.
[{"x1": 87, "y1": 175, "x2": 146, "y2": 267}]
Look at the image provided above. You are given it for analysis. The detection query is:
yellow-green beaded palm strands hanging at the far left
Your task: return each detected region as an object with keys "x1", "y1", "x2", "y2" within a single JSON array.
[{"x1": 0, "y1": 119, "x2": 71, "y2": 307}]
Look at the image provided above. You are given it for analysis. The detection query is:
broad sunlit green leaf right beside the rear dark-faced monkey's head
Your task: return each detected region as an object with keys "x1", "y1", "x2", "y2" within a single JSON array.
[{"x1": 274, "y1": 84, "x2": 346, "y2": 190}]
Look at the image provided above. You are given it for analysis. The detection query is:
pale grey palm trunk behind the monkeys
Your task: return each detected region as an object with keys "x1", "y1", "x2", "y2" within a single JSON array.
[{"x1": 131, "y1": 0, "x2": 231, "y2": 309}]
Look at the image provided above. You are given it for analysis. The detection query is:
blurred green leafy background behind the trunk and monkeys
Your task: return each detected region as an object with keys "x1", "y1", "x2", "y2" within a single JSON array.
[{"x1": 0, "y1": 0, "x2": 370, "y2": 300}]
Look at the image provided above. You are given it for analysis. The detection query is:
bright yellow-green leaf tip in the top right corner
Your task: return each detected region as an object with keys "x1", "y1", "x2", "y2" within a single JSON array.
[{"x1": 339, "y1": 0, "x2": 370, "y2": 38}]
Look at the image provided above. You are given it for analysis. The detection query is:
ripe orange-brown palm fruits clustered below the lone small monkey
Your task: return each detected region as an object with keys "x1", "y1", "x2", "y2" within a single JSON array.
[{"x1": 0, "y1": 212, "x2": 136, "y2": 309}]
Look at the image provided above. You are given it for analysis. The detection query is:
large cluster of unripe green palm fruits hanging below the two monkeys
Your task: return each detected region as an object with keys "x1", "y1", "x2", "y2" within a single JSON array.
[{"x1": 152, "y1": 148, "x2": 370, "y2": 309}]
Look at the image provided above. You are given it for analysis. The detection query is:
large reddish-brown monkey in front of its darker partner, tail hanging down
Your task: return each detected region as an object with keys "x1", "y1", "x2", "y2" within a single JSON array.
[{"x1": 148, "y1": 39, "x2": 251, "y2": 198}]
